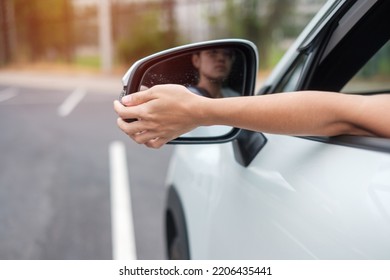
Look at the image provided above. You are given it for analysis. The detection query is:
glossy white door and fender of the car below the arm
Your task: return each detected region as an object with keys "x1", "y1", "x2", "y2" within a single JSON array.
[{"x1": 168, "y1": 135, "x2": 390, "y2": 259}]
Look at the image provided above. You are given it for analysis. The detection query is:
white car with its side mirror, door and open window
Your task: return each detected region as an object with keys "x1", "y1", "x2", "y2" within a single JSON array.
[{"x1": 124, "y1": 0, "x2": 390, "y2": 259}]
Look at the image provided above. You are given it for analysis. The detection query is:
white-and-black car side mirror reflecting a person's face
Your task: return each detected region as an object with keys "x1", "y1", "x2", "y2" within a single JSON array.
[{"x1": 121, "y1": 39, "x2": 258, "y2": 144}]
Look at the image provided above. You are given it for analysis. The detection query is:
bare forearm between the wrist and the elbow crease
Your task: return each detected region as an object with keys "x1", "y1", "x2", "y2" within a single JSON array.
[{"x1": 201, "y1": 92, "x2": 369, "y2": 136}]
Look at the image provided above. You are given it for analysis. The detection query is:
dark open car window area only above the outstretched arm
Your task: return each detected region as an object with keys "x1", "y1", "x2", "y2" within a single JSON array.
[{"x1": 305, "y1": 1, "x2": 390, "y2": 93}]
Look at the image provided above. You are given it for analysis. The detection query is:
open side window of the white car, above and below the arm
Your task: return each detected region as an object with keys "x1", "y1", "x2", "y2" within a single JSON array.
[{"x1": 302, "y1": 0, "x2": 390, "y2": 149}]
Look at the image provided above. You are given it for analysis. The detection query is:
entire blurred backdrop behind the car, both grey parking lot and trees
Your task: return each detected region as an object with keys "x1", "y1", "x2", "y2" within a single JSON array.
[{"x1": 0, "y1": 0, "x2": 336, "y2": 259}]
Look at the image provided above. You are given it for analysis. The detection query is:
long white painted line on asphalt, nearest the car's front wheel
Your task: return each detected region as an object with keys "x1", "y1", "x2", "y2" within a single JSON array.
[{"x1": 109, "y1": 141, "x2": 137, "y2": 260}]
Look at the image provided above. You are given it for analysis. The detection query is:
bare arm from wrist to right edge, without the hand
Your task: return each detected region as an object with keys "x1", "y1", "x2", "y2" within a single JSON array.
[{"x1": 209, "y1": 91, "x2": 390, "y2": 137}]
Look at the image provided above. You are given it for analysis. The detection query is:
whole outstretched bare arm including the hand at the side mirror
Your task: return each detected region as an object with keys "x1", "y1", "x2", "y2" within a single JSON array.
[{"x1": 115, "y1": 85, "x2": 390, "y2": 147}]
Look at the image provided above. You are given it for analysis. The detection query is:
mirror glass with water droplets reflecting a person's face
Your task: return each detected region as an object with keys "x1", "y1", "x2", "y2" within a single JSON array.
[{"x1": 139, "y1": 47, "x2": 246, "y2": 137}]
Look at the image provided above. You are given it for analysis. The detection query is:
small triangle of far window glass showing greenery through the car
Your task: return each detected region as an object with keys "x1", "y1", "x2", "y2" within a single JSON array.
[{"x1": 342, "y1": 41, "x2": 390, "y2": 93}]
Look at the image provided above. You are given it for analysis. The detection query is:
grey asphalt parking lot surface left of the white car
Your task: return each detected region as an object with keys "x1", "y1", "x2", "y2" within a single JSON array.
[{"x1": 0, "y1": 71, "x2": 173, "y2": 260}]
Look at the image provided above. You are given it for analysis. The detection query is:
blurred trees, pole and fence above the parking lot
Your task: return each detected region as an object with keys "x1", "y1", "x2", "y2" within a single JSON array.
[{"x1": 0, "y1": 0, "x2": 325, "y2": 72}]
